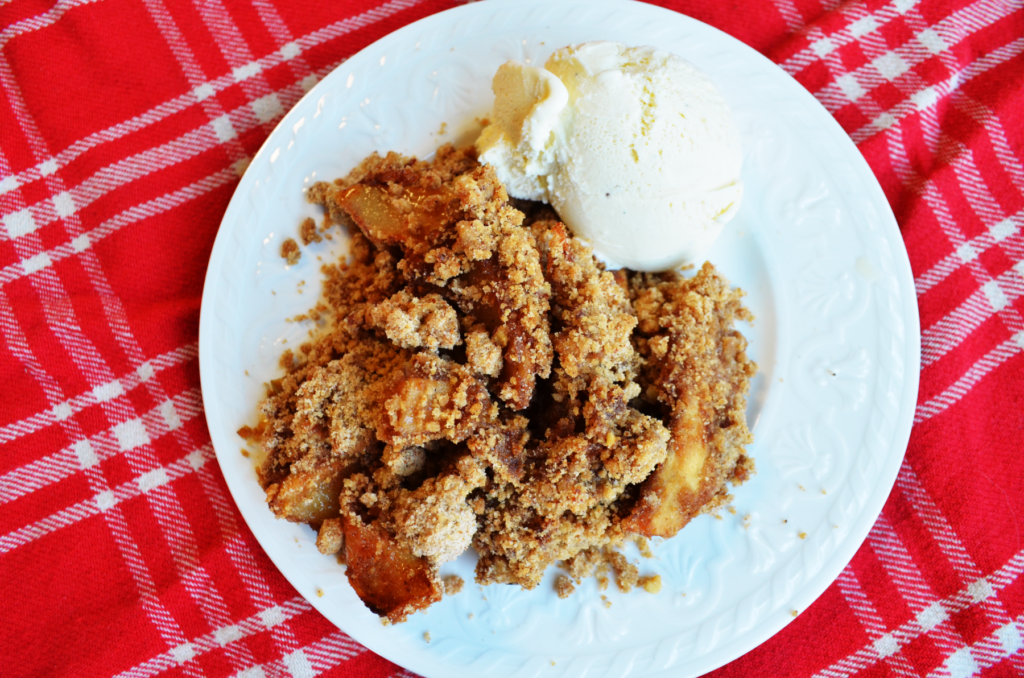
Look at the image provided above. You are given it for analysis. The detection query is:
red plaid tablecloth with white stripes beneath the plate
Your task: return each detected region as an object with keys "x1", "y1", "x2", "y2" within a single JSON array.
[{"x1": 0, "y1": 0, "x2": 1024, "y2": 678}]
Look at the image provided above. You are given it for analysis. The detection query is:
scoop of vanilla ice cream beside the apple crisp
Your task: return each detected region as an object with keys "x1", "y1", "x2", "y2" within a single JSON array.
[{"x1": 476, "y1": 42, "x2": 743, "y2": 270}]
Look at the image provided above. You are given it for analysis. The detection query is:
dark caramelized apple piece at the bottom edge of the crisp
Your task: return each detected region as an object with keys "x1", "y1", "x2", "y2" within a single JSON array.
[{"x1": 342, "y1": 513, "x2": 443, "y2": 624}]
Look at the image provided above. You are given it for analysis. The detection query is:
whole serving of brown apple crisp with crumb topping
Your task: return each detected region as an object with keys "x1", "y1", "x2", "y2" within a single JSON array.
[{"x1": 243, "y1": 146, "x2": 756, "y2": 622}]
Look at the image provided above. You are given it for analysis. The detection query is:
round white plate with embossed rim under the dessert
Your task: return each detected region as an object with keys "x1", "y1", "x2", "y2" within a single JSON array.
[{"x1": 200, "y1": 0, "x2": 920, "y2": 676}]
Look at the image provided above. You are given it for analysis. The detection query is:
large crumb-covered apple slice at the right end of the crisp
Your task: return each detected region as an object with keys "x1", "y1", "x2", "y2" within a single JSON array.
[{"x1": 625, "y1": 263, "x2": 757, "y2": 538}]
